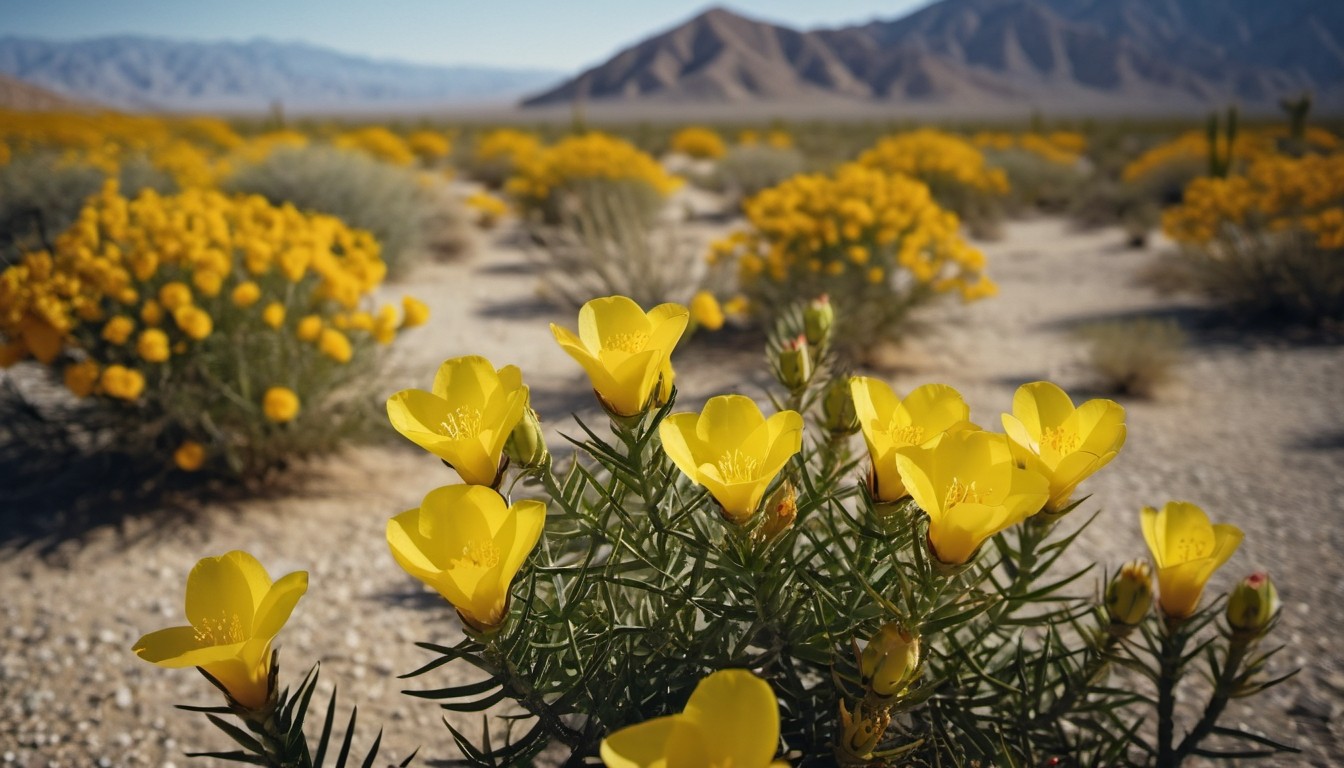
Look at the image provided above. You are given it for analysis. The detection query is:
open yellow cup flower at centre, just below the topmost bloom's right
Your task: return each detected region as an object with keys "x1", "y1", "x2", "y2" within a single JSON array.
[{"x1": 659, "y1": 394, "x2": 802, "y2": 525}]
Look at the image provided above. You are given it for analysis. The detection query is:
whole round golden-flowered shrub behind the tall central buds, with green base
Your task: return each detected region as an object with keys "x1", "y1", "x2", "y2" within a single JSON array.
[{"x1": 710, "y1": 164, "x2": 995, "y2": 355}]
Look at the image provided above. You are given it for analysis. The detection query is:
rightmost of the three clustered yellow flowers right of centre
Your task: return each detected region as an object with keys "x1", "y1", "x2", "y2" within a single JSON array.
[{"x1": 1003, "y1": 382, "x2": 1125, "y2": 514}]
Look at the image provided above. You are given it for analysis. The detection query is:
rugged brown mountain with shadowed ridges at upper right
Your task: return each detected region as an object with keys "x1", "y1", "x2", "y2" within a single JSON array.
[{"x1": 523, "y1": 0, "x2": 1344, "y2": 112}]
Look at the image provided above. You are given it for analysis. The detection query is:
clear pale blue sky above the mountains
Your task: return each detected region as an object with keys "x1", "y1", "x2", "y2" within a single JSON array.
[{"x1": 0, "y1": 0, "x2": 929, "y2": 71}]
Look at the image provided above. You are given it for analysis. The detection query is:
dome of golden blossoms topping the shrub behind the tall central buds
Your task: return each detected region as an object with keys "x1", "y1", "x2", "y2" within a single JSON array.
[{"x1": 710, "y1": 163, "x2": 995, "y2": 300}]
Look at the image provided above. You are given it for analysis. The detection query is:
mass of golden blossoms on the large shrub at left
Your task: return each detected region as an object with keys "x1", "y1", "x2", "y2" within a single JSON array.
[{"x1": 0, "y1": 182, "x2": 423, "y2": 408}]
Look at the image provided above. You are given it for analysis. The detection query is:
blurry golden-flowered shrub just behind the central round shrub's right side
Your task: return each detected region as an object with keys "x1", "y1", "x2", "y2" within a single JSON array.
[{"x1": 859, "y1": 129, "x2": 1008, "y2": 234}]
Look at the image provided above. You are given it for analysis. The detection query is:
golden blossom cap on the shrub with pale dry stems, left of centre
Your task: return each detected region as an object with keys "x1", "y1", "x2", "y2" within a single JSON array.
[{"x1": 507, "y1": 132, "x2": 681, "y2": 212}]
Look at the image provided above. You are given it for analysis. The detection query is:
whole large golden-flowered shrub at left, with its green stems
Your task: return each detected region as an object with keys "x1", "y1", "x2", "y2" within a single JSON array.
[{"x1": 0, "y1": 184, "x2": 425, "y2": 479}]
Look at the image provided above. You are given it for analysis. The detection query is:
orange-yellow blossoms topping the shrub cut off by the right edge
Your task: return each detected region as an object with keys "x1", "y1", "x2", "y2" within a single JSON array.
[{"x1": 1163, "y1": 149, "x2": 1344, "y2": 250}]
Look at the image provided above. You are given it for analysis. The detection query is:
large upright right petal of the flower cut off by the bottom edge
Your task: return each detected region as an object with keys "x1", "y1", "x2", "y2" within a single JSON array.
[{"x1": 683, "y1": 670, "x2": 780, "y2": 767}]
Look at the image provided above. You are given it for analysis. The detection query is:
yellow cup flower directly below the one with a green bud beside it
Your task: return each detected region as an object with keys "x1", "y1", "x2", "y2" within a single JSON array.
[{"x1": 387, "y1": 486, "x2": 546, "y2": 631}]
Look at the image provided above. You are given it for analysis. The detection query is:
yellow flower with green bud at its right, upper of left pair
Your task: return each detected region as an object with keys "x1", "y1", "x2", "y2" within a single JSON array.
[{"x1": 387, "y1": 355, "x2": 527, "y2": 486}]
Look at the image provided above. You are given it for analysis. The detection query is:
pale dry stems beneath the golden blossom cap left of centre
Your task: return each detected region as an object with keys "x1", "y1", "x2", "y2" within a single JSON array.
[{"x1": 530, "y1": 186, "x2": 704, "y2": 308}]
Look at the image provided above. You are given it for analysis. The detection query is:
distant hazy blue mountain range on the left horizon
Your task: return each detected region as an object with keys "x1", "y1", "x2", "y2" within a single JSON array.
[{"x1": 0, "y1": 36, "x2": 560, "y2": 112}]
